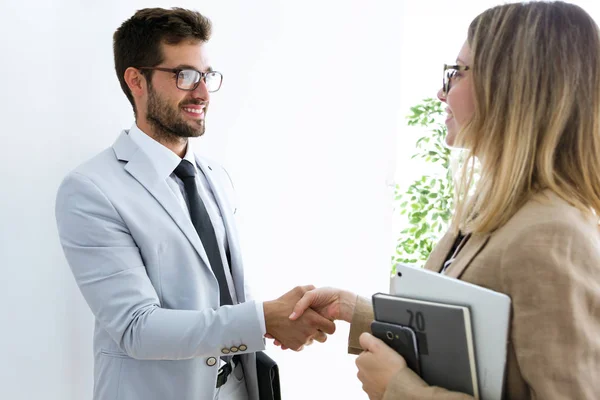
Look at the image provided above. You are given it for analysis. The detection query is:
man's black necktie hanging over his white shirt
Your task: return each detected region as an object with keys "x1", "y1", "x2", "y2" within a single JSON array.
[{"x1": 174, "y1": 160, "x2": 233, "y2": 305}]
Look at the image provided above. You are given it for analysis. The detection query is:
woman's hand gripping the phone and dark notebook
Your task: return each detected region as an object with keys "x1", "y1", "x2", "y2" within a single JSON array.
[{"x1": 356, "y1": 332, "x2": 407, "y2": 400}]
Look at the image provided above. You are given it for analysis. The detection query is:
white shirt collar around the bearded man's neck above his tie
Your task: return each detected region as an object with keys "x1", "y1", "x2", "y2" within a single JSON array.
[{"x1": 129, "y1": 123, "x2": 198, "y2": 179}]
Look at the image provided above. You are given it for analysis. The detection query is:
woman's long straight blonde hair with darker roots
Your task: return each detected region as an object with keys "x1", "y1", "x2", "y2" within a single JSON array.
[{"x1": 452, "y1": 2, "x2": 600, "y2": 233}]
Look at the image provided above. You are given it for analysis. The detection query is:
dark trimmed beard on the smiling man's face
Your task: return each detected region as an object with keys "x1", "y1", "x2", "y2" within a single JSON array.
[{"x1": 146, "y1": 86, "x2": 206, "y2": 141}]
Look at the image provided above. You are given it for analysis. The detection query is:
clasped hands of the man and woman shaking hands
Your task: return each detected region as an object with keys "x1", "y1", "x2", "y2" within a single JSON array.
[{"x1": 263, "y1": 285, "x2": 357, "y2": 351}]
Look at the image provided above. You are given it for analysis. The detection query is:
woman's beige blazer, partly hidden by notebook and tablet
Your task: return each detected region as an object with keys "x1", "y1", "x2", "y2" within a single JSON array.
[{"x1": 348, "y1": 192, "x2": 600, "y2": 400}]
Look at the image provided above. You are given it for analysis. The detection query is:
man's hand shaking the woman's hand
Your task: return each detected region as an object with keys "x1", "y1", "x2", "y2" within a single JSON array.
[{"x1": 263, "y1": 285, "x2": 335, "y2": 351}]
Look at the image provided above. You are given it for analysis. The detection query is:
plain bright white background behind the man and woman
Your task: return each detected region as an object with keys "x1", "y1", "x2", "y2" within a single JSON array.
[{"x1": 0, "y1": 0, "x2": 594, "y2": 400}]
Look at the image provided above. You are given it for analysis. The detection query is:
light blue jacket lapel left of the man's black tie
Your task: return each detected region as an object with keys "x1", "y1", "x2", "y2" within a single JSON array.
[{"x1": 113, "y1": 131, "x2": 212, "y2": 272}]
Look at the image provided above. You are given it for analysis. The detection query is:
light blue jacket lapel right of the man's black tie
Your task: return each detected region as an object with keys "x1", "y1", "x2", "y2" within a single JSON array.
[{"x1": 196, "y1": 156, "x2": 246, "y2": 303}]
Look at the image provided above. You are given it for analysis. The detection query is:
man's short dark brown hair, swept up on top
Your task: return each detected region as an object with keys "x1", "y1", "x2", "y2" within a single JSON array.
[{"x1": 113, "y1": 7, "x2": 211, "y2": 113}]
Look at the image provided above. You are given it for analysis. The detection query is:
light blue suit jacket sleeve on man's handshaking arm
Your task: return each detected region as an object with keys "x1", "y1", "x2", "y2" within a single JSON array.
[{"x1": 56, "y1": 173, "x2": 264, "y2": 360}]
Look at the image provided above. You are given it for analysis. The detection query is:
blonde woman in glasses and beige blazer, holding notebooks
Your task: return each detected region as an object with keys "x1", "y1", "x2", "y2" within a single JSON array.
[{"x1": 290, "y1": 2, "x2": 600, "y2": 400}]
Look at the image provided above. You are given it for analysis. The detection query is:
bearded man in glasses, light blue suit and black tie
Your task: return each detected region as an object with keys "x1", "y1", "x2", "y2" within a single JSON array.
[{"x1": 56, "y1": 8, "x2": 335, "y2": 400}]
